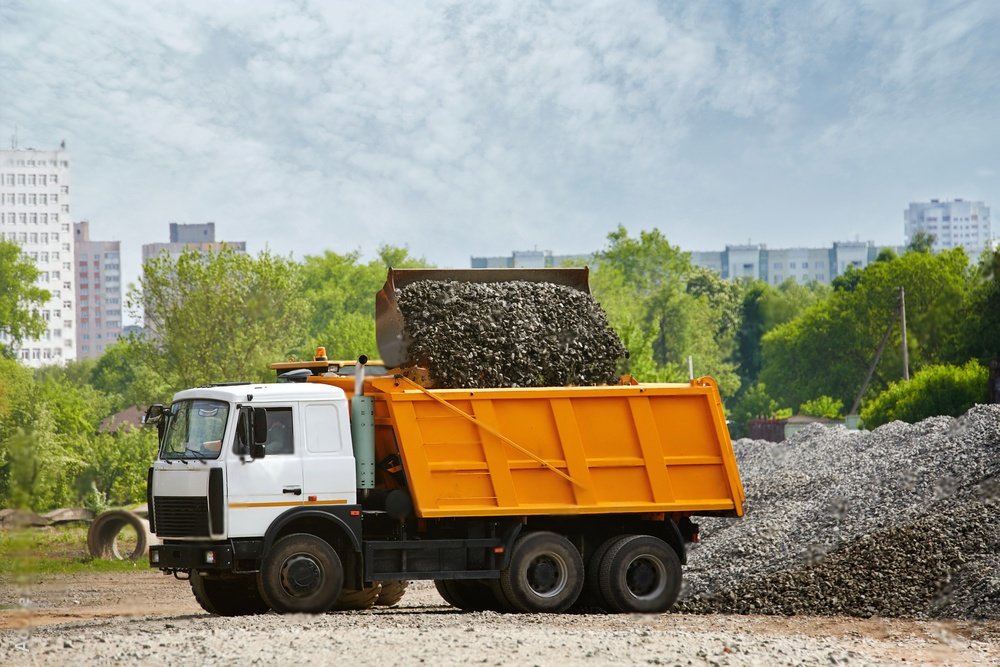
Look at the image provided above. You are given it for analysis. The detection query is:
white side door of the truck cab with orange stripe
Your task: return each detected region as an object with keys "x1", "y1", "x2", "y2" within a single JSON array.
[{"x1": 226, "y1": 406, "x2": 305, "y2": 537}]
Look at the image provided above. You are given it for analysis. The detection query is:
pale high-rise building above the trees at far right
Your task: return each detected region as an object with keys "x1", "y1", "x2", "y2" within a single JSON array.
[{"x1": 903, "y1": 199, "x2": 993, "y2": 261}]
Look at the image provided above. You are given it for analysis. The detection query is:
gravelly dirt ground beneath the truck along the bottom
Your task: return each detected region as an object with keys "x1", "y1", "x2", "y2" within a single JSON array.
[{"x1": 0, "y1": 570, "x2": 1000, "y2": 667}]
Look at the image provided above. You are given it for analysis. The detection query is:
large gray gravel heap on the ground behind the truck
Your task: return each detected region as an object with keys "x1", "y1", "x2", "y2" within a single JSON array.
[{"x1": 678, "y1": 405, "x2": 1000, "y2": 619}]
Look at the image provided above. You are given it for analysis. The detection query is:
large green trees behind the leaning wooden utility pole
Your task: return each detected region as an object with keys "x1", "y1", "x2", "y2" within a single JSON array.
[{"x1": 760, "y1": 250, "x2": 969, "y2": 405}]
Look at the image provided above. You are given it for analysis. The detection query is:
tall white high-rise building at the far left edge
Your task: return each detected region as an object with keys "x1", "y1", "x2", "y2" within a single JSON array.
[{"x1": 0, "y1": 144, "x2": 76, "y2": 367}]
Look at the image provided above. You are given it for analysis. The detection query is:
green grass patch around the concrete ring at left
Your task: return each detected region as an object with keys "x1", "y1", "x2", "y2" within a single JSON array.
[{"x1": 0, "y1": 525, "x2": 149, "y2": 576}]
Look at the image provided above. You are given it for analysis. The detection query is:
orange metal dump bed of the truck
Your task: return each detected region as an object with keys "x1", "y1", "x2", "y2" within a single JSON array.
[{"x1": 365, "y1": 376, "x2": 744, "y2": 518}]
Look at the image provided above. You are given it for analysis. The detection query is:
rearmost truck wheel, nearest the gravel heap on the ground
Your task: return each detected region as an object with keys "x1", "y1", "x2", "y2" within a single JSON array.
[{"x1": 599, "y1": 535, "x2": 681, "y2": 614}]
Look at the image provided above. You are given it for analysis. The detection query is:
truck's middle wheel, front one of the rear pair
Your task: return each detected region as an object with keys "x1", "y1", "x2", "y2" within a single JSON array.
[{"x1": 500, "y1": 531, "x2": 584, "y2": 613}]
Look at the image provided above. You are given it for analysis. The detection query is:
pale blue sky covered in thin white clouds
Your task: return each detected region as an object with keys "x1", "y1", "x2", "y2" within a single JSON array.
[{"x1": 0, "y1": 0, "x2": 1000, "y2": 292}]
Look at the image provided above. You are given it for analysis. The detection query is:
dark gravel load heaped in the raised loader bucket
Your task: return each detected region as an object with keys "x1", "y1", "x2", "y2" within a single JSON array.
[{"x1": 397, "y1": 280, "x2": 626, "y2": 387}]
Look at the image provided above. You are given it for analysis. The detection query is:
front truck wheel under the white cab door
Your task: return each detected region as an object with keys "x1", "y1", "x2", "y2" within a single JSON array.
[{"x1": 257, "y1": 533, "x2": 344, "y2": 614}]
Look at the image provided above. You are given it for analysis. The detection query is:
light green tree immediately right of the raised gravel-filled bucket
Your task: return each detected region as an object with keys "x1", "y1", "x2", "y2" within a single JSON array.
[{"x1": 591, "y1": 226, "x2": 741, "y2": 394}]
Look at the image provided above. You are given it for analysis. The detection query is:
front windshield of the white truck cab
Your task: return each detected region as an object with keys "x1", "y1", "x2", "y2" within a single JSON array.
[{"x1": 160, "y1": 399, "x2": 229, "y2": 459}]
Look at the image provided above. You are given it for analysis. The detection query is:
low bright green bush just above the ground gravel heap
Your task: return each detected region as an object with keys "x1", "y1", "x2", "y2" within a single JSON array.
[{"x1": 861, "y1": 360, "x2": 989, "y2": 428}]
